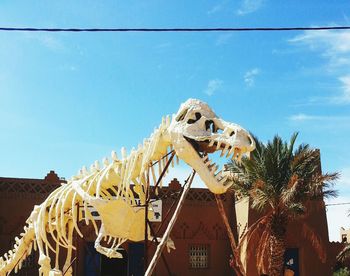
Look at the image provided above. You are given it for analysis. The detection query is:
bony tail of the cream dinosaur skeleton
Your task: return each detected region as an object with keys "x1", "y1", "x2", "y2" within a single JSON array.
[{"x1": 0, "y1": 219, "x2": 36, "y2": 276}]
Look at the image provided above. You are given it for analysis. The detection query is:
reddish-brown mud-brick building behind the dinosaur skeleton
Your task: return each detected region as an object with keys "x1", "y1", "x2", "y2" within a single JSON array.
[{"x1": 0, "y1": 171, "x2": 343, "y2": 276}]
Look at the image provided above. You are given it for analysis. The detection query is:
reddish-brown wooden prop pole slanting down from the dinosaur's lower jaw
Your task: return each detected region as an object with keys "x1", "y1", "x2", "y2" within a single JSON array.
[{"x1": 215, "y1": 194, "x2": 244, "y2": 276}]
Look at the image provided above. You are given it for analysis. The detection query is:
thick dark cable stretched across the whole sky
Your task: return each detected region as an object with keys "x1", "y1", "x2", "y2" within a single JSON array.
[{"x1": 0, "y1": 26, "x2": 350, "y2": 32}]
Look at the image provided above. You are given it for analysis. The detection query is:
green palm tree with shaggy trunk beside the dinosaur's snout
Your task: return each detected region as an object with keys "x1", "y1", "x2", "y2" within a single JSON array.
[{"x1": 228, "y1": 133, "x2": 338, "y2": 276}]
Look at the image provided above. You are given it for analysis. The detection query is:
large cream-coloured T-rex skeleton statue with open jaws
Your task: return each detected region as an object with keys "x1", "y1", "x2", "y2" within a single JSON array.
[{"x1": 0, "y1": 99, "x2": 255, "y2": 276}]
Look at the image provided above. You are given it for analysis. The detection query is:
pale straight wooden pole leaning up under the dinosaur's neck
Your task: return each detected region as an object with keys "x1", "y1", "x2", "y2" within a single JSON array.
[{"x1": 145, "y1": 170, "x2": 196, "y2": 276}]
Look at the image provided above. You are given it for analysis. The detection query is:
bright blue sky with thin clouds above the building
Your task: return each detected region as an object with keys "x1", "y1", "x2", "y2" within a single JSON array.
[{"x1": 0, "y1": 0, "x2": 350, "y2": 239}]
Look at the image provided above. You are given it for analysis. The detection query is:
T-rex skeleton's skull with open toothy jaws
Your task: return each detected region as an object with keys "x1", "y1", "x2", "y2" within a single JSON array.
[{"x1": 168, "y1": 99, "x2": 255, "y2": 194}]
